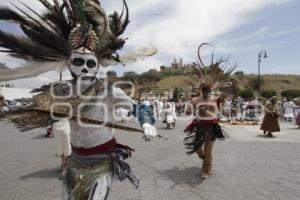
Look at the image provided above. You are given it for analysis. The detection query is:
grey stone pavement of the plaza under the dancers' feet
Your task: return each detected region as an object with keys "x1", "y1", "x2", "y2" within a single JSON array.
[{"x1": 0, "y1": 121, "x2": 300, "y2": 200}]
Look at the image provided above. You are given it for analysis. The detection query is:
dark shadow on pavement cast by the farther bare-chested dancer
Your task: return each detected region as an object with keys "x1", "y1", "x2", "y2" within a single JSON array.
[{"x1": 161, "y1": 167, "x2": 203, "y2": 187}]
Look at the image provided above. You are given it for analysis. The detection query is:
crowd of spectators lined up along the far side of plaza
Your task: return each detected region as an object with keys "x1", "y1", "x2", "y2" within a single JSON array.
[{"x1": 129, "y1": 96, "x2": 300, "y2": 125}]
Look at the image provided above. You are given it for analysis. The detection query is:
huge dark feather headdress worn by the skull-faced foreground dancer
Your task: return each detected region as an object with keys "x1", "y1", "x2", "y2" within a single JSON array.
[{"x1": 0, "y1": 0, "x2": 157, "y2": 81}]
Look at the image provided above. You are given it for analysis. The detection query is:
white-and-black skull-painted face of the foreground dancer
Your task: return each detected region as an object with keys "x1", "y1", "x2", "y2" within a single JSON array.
[{"x1": 69, "y1": 52, "x2": 99, "y2": 83}]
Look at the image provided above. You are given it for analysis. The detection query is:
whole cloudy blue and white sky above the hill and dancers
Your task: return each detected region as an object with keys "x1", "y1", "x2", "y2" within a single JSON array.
[{"x1": 0, "y1": 0, "x2": 300, "y2": 87}]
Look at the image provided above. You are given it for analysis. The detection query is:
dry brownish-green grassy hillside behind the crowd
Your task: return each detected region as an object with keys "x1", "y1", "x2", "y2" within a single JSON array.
[{"x1": 154, "y1": 75, "x2": 300, "y2": 94}]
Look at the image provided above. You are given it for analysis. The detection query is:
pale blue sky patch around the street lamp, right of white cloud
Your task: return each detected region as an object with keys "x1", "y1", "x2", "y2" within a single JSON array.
[{"x1": 214, "y1": 1, "x2": 300, "y2": 74}]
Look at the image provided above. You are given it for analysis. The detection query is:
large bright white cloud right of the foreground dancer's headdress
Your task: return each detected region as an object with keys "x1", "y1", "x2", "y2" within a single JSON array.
[{"x1": 108, "y1": 0, "x2": 287, "y2": 59}]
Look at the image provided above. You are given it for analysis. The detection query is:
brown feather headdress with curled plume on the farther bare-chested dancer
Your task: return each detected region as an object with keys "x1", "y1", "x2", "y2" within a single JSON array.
[{"x1": 185, "y1": 43, "x2": 236, "y2": 90}]
